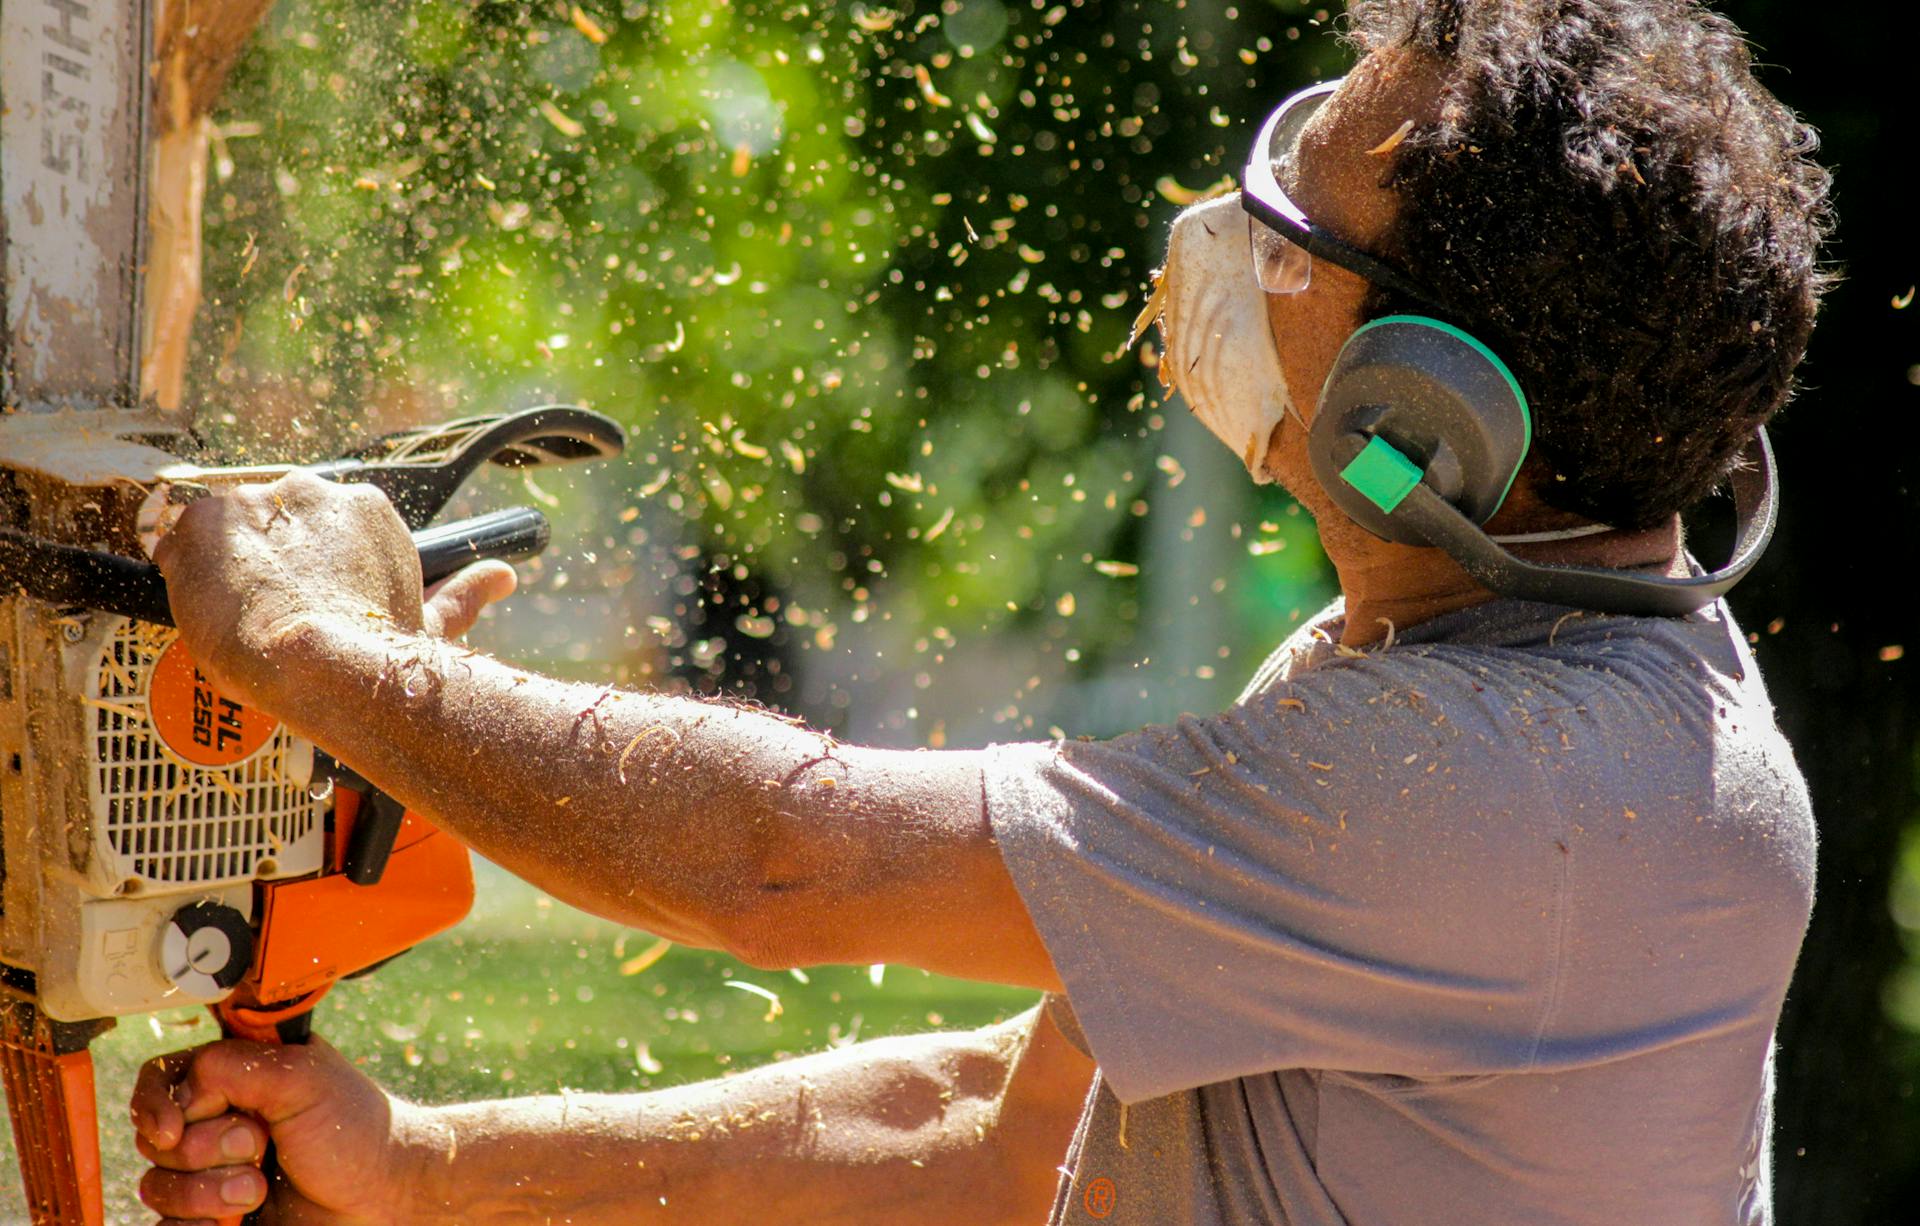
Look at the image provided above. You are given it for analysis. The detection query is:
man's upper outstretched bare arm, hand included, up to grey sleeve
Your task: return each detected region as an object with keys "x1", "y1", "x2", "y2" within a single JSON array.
[{"x1": 159, "y1": 476, "x2": 1058, "y2": 988}]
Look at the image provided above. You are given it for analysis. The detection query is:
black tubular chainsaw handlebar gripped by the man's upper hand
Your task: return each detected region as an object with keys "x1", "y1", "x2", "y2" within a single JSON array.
[{"x1": 0, "y1": 507, "x2": 553, "y2": 625}]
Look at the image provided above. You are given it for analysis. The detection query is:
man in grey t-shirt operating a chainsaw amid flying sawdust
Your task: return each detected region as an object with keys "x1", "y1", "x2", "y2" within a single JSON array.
[{"x1": 132, "y1": 0, "x2": 1826, "y2": 1226}]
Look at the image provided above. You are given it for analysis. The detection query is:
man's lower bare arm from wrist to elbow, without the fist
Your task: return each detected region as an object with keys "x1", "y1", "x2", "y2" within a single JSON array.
[{"x1": 397, "y1": 1013, "x2": 1091, "y2": 1226}]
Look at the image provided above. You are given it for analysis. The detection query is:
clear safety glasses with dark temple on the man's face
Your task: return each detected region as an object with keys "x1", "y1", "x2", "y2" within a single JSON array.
[{"x1": 1240, "y1": 77, "x2": 1442, "y2": 315}]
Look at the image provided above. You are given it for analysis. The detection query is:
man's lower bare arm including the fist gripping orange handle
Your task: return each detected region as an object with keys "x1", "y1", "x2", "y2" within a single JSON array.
[{"x1": 132, "y1": 1009, "x2": 1092, "y2": 1226}]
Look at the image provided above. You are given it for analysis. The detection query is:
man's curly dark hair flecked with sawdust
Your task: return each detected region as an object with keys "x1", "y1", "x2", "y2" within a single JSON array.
[{"x1": 1348, "y1": 0, "x2": 1832, "y2": 528}]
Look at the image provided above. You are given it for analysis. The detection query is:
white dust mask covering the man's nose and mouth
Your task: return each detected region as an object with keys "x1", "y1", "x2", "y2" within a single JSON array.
[{"x1": 1129, "y1": 192, "x2": 1304, "y2": 485}]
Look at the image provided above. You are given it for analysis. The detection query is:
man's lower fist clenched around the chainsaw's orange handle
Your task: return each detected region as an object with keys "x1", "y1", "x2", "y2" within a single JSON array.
[{"x1": 132, "y1": 1040, "x2": 433, "y2": 1226}]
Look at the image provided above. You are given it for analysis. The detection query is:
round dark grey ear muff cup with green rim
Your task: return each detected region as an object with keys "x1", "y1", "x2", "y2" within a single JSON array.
[{"x1": 1308, "y1": 315, "x2": 1532, "y2": 545}]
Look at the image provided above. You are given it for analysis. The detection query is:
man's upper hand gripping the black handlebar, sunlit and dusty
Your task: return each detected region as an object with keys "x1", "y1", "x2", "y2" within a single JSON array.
[{"x1": 154, "y1": 472, "x2": 428, "y2": 710}]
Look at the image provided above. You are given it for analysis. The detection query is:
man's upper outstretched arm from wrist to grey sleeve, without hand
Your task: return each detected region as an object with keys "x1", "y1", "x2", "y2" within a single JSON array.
[{"x1": 255, "y1": 618, "x2": 1054, "y2": 986}]
